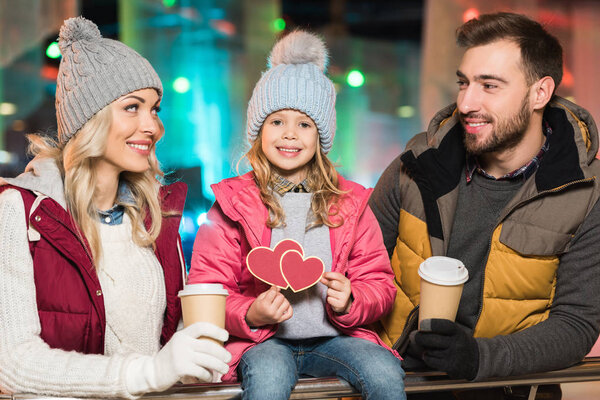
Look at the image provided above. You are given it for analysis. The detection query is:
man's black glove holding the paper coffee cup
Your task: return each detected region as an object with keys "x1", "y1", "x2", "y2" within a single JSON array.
[{"x1": 415, "y1": 319, "x2": 479, "y2": 380}]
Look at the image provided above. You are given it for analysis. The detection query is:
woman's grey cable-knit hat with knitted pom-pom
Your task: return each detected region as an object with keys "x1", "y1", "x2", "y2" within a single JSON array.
[{"x1": 56, "y1": 17, "x2": 163, "y2": 144}]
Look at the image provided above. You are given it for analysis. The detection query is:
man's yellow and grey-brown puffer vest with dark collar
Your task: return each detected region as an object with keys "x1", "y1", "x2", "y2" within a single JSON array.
[{"x1": 376, "y1": 97, "x2": 600, "y2": 346}]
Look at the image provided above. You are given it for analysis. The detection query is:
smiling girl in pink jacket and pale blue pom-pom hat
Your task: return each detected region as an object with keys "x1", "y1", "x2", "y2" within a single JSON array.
[{"x1": 188, "y1": 31, "x2": 405, "y2": 400}]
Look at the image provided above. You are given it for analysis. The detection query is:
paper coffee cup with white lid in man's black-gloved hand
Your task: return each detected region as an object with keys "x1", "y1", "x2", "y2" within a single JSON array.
[{"x1": 419, "y1": 256, "x2": 469, "y2": 329}]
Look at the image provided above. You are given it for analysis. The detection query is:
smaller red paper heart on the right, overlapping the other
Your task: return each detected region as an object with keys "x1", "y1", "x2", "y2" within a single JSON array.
[{"x1": 281, "y1": 250, "x2": 325, "y2": 292}]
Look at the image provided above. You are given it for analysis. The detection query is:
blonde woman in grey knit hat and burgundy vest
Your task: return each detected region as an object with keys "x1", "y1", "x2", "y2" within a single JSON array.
[{"x1": 0, "y1": 17, "x2": 230, "y2": 398}]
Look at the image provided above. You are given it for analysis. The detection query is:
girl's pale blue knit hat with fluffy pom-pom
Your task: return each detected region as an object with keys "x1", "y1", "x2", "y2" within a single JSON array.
[{"x1": 246, "y1": 31, "x2": 335, "y2": 153}]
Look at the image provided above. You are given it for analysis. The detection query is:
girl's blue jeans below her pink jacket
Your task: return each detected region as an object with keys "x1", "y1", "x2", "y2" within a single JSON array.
[{"x1": 238, "y1": 336, "x2": 406, "y2": 400}]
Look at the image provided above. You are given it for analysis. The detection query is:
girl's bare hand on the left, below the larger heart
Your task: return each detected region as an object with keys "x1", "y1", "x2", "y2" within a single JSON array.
[{"x1": 246, "y1": 286, "x2": 294, "y2": 328}]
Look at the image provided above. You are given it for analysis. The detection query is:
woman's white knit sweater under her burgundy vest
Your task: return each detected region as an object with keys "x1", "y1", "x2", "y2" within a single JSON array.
[{"x1": 0, "y1": 190, "x2": 166, "y2": 397}]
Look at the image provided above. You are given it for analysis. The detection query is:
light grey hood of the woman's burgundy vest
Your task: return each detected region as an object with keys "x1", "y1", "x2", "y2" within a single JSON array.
[{"x1": 0, "y1": 158, "x2": 67, "y2": 210}]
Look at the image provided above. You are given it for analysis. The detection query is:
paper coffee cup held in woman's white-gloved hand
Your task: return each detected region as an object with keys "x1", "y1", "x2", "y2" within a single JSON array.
[{"x1": 178, "y1": 283, "x2": 229, "y2": 344}]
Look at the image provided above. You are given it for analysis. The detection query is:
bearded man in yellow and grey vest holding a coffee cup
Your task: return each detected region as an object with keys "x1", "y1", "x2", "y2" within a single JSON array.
[{"x1": 370, "y1": 13, "x2": 600, "y2": 396}]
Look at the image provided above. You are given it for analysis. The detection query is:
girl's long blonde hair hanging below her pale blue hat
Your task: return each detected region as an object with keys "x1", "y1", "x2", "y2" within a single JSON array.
[{"x1": 244, "y1": 129, "x2": 346, "y2": 229}]
